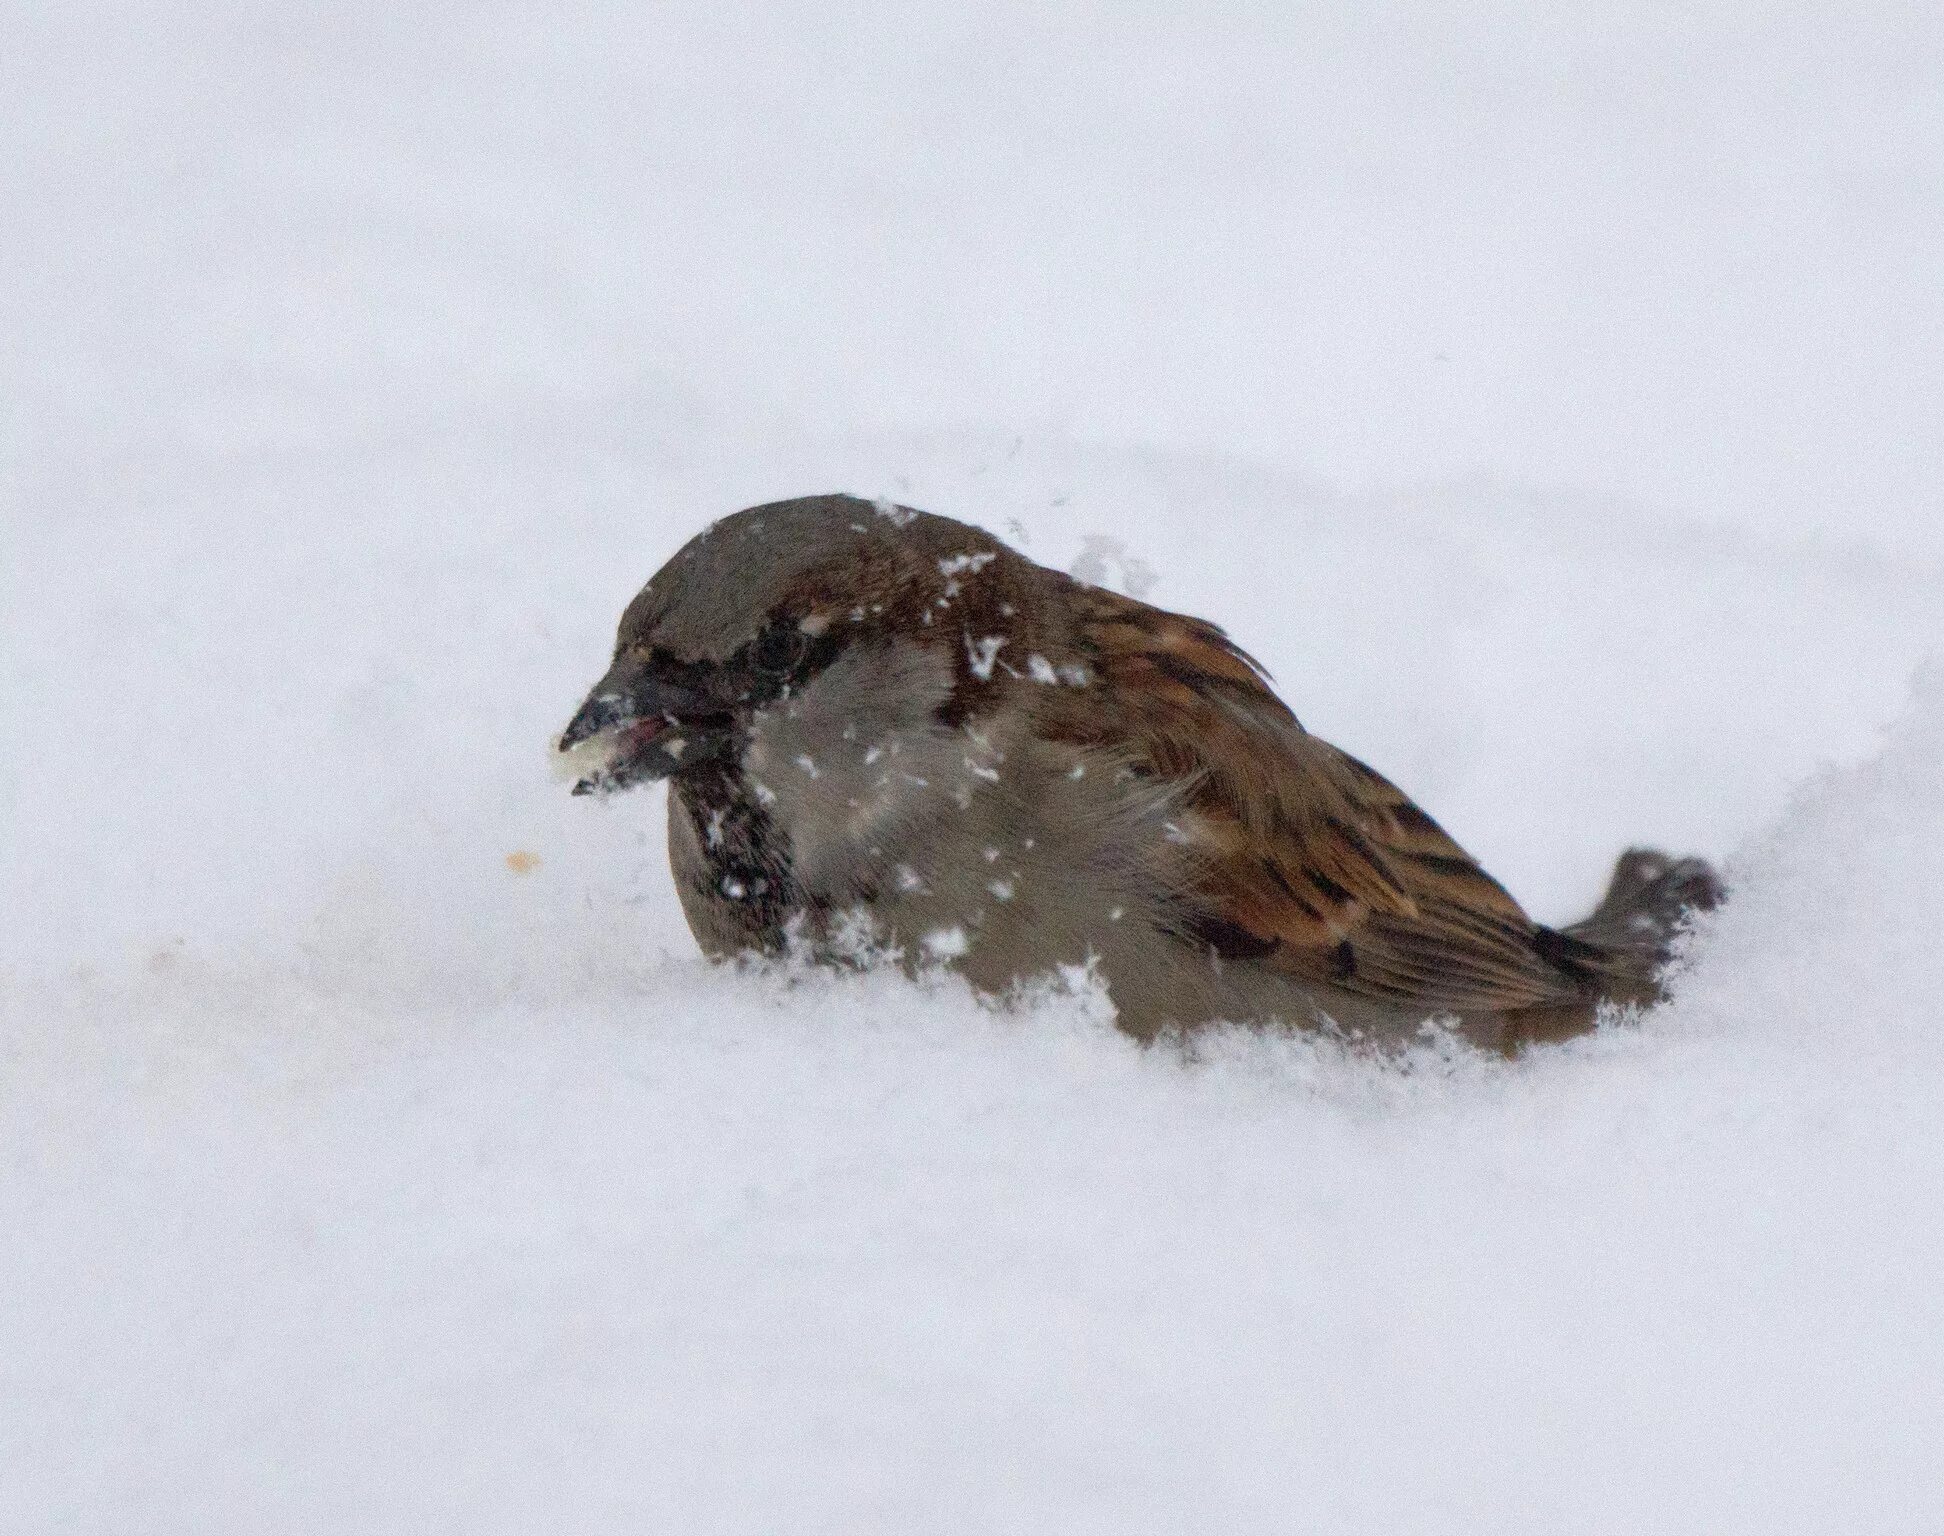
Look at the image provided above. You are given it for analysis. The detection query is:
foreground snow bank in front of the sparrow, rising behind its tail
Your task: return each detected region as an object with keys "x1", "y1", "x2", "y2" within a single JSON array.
[{"x1": 0, "y1": 673, "x2": 1944, "y2": 1532}]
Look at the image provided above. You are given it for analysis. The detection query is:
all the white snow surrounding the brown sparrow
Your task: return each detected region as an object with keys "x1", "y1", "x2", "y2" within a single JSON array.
[{"x1": 0, "y1": 0, "x2": 1944, "y2": 1536}]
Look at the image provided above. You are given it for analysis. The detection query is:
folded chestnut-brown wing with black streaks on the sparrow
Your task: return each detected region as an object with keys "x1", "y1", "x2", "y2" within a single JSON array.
[{"x1": 1077, "y1": 589, "x2": 1588, "y2": 1013}]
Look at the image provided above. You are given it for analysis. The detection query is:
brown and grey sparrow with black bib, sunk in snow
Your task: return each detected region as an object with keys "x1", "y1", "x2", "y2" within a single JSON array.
[{"x1": 558, "y1": 496, "x2": 1720, "y2": 1050}]
